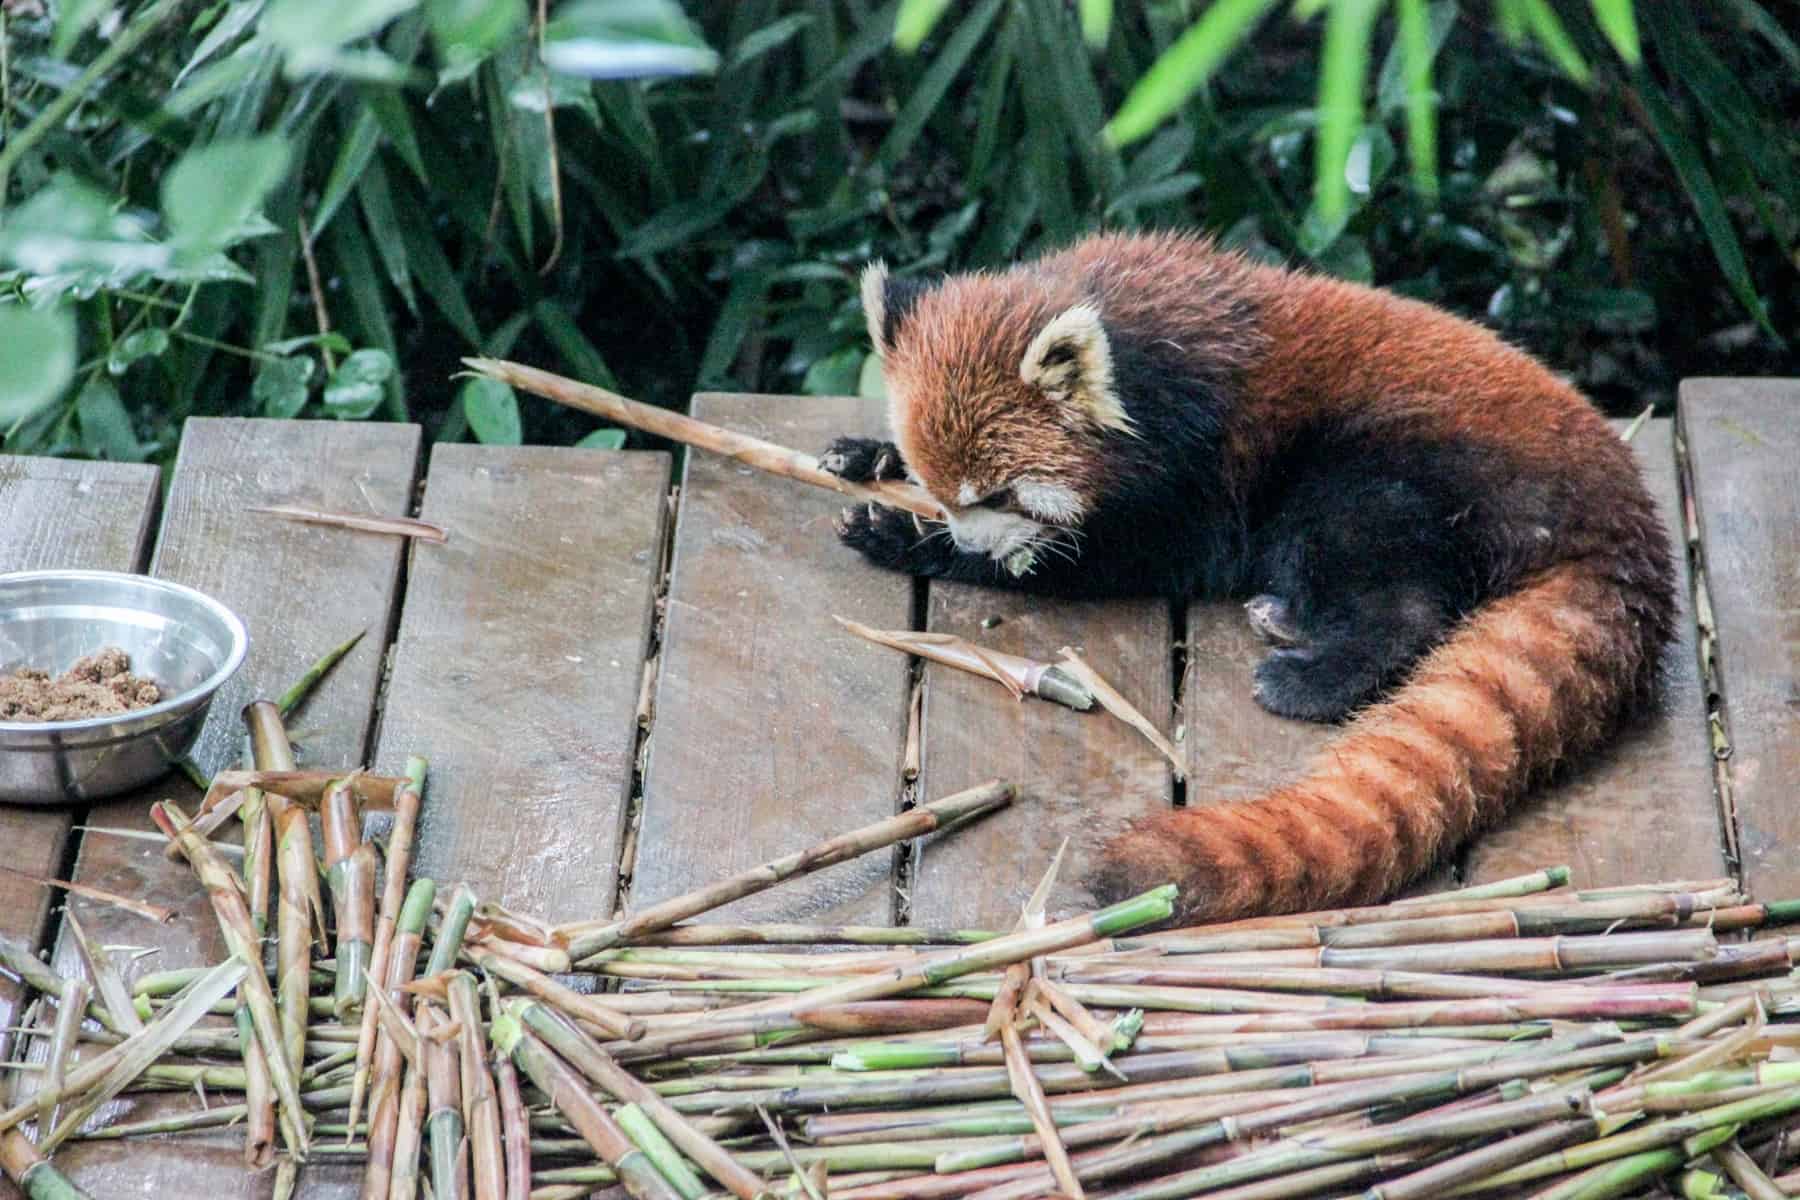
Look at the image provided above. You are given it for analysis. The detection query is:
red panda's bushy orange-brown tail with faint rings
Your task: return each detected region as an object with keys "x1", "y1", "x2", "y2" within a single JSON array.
[{"x1": 1091, "y1": 560, "x2": 1674, "y2": 921}]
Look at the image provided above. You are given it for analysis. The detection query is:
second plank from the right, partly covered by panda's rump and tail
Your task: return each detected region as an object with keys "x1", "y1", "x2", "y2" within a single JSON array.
[{"x1": 1465, "y1": 421, "x2": 1724, "y2": 887}]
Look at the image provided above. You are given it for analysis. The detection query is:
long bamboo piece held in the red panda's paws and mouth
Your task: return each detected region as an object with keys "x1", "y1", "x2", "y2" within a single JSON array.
[{"x1": 463, "y1": 358, "x2": 943, "y2": 520}]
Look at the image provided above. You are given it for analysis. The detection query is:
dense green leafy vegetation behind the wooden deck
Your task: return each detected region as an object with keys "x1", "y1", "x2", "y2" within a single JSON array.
[{"x1": 0, "y1": 0, "x2": 1800, "y2": 474}]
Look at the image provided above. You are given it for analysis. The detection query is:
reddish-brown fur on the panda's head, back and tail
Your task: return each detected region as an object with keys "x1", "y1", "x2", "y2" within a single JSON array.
[{"x1": 871, "y1": 236, "x2": 1672, "y2": 919}]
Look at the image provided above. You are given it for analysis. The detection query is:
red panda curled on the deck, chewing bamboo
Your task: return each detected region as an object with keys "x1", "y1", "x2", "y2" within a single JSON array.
[{"x1": 823, "y1": 234, "x2": 1678, "y2": 919}]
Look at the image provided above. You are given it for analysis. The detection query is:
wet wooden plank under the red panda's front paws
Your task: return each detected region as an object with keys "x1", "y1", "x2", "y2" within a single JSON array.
[{"x1": 632, "y1": 396, "x2": 913, "y2": 923}]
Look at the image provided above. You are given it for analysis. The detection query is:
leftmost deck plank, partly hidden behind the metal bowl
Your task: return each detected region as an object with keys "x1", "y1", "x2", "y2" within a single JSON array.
[{"x1": 0, "y1": 455, "x2": 158, "y2": 1056}]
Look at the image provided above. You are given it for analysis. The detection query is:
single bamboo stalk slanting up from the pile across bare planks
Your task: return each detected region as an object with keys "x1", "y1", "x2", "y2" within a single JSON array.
[{"x1": 569, "y1": 781, "x2": 1017, "y2": 963}]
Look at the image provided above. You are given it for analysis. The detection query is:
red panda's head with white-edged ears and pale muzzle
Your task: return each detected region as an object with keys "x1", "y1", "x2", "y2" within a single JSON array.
[{"x1": 862, "y1": 264, "x2": 1130, "y2": 560}]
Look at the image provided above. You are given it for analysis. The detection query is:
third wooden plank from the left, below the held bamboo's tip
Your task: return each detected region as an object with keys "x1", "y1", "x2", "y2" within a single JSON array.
[{"x1": 376, "y1": 444, "x2": 670, "y2": 921}]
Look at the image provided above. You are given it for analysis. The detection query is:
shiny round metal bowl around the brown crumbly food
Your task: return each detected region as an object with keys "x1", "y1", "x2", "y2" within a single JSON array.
[{"x1": 0, "y1": 570, "x2": 250, "y2": 804}]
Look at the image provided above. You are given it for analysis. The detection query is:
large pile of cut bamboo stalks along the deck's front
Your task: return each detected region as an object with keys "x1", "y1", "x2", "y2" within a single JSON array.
[{"x1": 0, "y1": 703, "x2": 1800, "y2": 1200}]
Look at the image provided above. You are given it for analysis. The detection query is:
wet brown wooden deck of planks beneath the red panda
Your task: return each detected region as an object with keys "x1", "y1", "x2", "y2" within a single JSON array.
[{"x1": 0, "y1": 380, "x2": 1800, "y2": 1200}]
